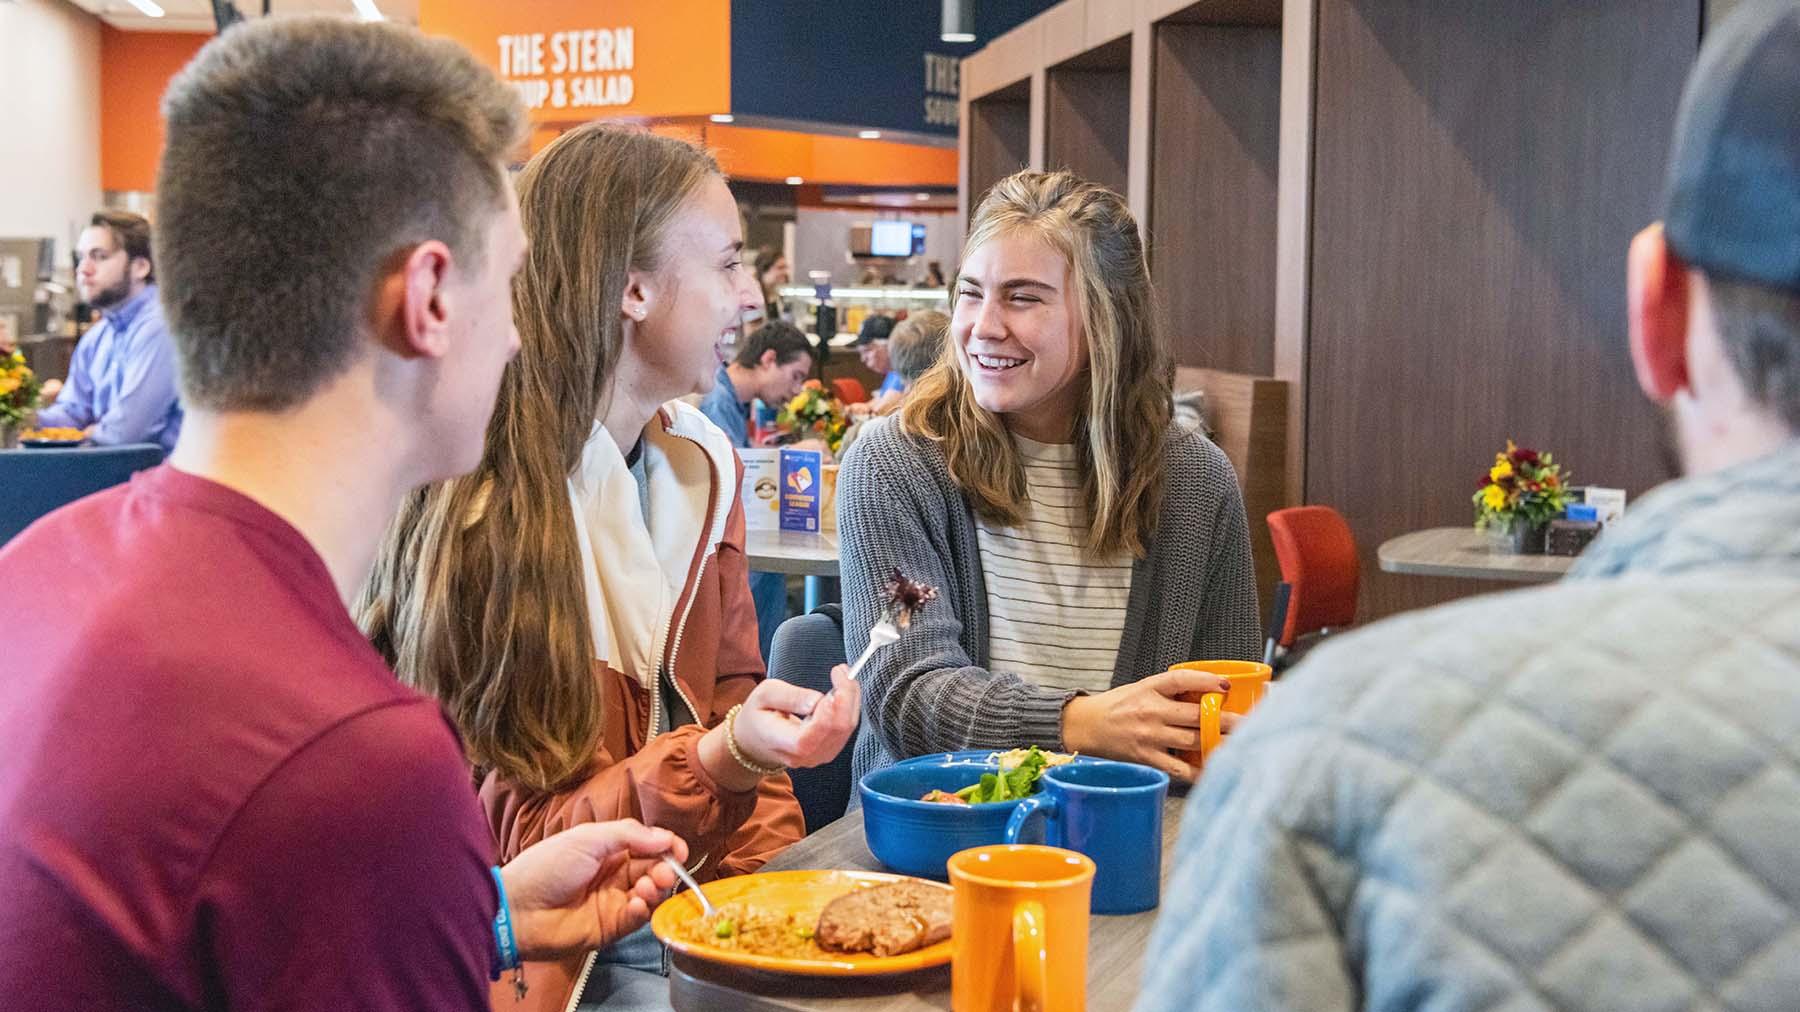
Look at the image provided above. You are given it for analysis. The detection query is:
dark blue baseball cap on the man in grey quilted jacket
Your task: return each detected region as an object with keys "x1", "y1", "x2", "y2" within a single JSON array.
[{"x1": 1663, "y1": 0, "x2": 1800, "y2": 292}]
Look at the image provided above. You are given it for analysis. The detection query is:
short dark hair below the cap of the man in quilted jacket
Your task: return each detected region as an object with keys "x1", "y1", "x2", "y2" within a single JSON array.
[{"x1": 1706, "y1": 276, "x2": 1800, "y2": 434}]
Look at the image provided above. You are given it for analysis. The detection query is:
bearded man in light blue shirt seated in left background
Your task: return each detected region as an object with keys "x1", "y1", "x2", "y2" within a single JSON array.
[{"x1": 38, "y1": 211, "x2": 182, "y2": 452}]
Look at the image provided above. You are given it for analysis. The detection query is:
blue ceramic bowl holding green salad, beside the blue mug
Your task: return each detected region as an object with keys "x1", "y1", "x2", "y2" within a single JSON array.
[{"x1": 857, "y1": 751, "x2": 1072, "y2": 881}]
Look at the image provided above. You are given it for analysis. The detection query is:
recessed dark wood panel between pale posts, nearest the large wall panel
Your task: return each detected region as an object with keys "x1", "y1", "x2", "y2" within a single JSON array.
[{"x1": 1148, "y1": 23, "x2": 1282, "y2": 376}]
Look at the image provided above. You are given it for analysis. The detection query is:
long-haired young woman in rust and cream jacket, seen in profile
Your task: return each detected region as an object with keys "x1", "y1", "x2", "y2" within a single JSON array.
[{"x1": 362, "y1": 124, "x2": 860, "y2": 1008}]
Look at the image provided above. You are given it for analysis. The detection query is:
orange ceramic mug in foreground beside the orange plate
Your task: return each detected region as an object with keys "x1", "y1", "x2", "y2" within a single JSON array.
[{"x1": 950, "y1": 845, "x2": 1094, "y2": 1012}]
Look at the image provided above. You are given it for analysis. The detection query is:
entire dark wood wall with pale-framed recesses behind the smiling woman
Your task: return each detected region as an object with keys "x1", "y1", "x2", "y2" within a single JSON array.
[{"x1": 963, "y1": 0, "x2": 1706, "y2": 618}]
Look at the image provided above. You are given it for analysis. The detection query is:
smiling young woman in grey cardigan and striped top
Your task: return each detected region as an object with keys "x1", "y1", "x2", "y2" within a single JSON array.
[{"x1": 839, "y1": 171, "x2": 1260, "y2": 780}]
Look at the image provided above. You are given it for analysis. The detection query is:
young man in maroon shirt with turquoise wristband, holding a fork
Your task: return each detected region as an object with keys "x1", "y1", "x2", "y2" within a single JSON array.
[{"x1": 0, "y1": 20, "x2": 702, "y2": 1010}]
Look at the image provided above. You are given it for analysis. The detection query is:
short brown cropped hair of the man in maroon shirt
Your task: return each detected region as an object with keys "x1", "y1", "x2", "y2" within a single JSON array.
[{"x1": 157, "y1": 16, "x2": 526, "y2": 411}]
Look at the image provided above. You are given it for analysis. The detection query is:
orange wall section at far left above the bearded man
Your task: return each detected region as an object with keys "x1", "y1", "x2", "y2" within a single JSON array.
[{"x1": 101, "y1": 25, "x2": 212, "y2": 191}]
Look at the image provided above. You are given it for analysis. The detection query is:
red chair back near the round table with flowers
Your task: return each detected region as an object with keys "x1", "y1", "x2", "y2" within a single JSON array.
[{"x1": 1265, "y1": 506, "x2": 1363, "y2": 659}]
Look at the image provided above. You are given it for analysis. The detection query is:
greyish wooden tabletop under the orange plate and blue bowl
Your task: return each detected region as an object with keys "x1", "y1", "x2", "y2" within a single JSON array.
[{"x1": 670, "y1": 794, "x2": 1186, "y2": 1012}]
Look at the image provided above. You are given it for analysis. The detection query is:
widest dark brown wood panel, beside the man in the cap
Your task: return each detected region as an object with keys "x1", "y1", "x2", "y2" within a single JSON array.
[{"x1": 1305, "y1": 0, "x2": 1701, "y2": 616}]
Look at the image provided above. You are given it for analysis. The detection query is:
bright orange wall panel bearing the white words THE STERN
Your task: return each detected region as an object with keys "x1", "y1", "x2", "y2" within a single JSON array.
[{"x1": 419, "y1": 0, "x2": 731, "y2": 124}]
